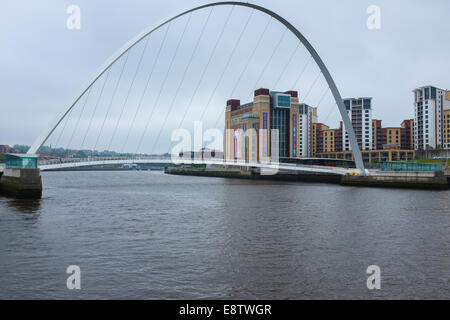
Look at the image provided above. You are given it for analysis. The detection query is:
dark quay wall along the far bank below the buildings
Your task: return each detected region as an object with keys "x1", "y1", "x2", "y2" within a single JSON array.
[{"x1": 164, "y1": 167, "x2": 449, "y2": 190}]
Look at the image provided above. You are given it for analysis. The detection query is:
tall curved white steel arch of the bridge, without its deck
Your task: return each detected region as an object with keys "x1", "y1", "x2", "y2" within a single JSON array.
[{"x1": 28, "y1": 1, "x2": 365, "y2": 175}]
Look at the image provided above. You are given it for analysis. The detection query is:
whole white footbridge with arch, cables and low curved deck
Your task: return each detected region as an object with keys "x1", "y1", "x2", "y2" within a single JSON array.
[{"x1": 23, "y1": 1, "x2": 366, "y2": 175}]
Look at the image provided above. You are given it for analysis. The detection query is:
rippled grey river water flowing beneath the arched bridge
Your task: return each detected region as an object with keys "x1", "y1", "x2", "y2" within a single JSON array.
[{"x1": 0, "y1": 171, "x2": 450, "y2": 299}]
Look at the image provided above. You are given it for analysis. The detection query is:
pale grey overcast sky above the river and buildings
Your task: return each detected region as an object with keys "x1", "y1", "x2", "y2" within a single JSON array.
[{"x1": 0, "y1": 0, "x2": 450, "y2": 151}]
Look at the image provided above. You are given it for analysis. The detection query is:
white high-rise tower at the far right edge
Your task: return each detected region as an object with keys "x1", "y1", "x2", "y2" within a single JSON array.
[{"x1": 413, "y1": 86, "x2": 450, "y2": 150}]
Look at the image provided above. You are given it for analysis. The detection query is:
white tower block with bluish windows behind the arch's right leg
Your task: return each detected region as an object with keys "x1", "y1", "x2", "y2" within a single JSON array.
[{"x1": 342, "y1": 98, "x2": 373, "y2": 151}]
